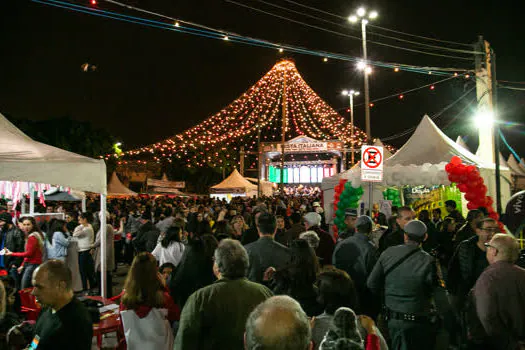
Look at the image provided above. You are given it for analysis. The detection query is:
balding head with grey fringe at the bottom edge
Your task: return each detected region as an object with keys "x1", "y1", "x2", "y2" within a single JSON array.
[{"x1": 246, "y1": 296, "x2": 311, "y2": 350}]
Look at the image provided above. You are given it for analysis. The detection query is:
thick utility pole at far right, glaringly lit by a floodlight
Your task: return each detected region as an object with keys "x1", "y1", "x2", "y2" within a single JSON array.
[{"x1": 475, "y1": 36, "x2": 502, "y2": 215}]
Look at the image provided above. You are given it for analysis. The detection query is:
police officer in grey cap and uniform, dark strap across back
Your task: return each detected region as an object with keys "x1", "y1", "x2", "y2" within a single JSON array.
[{"x1": 367, "y1": 220, "x2": 438, "y2": 350}]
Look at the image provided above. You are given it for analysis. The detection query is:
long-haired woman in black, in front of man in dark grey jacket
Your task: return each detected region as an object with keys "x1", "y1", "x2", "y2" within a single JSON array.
[{"x1": 265, "y1": 239, "x2": 322, "y2": 316}]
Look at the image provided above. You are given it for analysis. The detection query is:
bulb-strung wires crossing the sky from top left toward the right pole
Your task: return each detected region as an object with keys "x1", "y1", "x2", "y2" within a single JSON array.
[{"x1": 32, "y1": 0, "x2": 466, "y2": 75}]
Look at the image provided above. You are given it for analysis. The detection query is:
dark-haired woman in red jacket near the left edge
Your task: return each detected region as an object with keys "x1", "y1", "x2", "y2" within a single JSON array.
[{"x1": 5, "y1": 216, "x2": 45, "y2": 289}]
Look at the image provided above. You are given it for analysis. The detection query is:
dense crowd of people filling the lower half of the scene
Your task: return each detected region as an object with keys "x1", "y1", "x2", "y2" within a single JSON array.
[{"x1": 0, "y1": 193, "x2": 525, "y2": 350}]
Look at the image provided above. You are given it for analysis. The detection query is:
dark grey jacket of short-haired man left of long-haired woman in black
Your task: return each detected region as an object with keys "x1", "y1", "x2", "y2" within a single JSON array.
[{"x1": 245, "y1": 236, "x2": 290, "y2": 283}]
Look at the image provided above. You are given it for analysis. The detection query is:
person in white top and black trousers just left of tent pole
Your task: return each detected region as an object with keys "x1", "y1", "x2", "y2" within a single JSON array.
[{"x1": 73, "y1": 212, "x2": 96, "y2": 291}]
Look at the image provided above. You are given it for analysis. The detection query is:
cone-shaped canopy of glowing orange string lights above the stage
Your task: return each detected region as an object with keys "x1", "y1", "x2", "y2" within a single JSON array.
[{"x1": 110, "y1": 60, "x2": 366, "y2": 167}]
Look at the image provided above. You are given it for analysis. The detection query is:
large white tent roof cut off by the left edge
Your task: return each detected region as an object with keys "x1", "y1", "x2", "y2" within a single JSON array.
[{"x1": 0, "y1": 114, "x2": 106, "y2": 194}]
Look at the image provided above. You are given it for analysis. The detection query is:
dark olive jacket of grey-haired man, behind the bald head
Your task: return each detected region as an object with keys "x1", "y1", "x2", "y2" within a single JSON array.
[{"x1": 174, "y1": 278, "x2": 272, "y2": 350}]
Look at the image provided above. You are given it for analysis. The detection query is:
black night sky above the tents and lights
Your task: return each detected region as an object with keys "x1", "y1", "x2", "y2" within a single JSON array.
[{"x1": 0, "y1": 0, "x2": 525, "y2": 156}]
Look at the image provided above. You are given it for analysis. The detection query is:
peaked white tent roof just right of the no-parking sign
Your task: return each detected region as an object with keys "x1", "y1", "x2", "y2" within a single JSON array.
[{"x1": 385, "y1": 115, "x2": 483, "y2": 166}]
